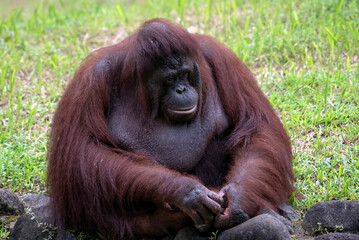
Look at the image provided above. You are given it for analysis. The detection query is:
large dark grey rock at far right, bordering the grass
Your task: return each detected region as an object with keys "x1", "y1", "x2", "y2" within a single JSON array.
[{"x1": 302, "y1": 200, "x2": 359, "y2": 233}]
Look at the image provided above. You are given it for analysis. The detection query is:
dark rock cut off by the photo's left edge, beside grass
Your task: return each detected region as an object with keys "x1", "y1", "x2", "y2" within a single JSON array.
[{"x1": 0, "y1": 189, "x2": 24, "y2": 215}]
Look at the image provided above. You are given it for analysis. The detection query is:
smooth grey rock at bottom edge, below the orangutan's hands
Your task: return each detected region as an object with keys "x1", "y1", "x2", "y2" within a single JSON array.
[{"x1": 217, "y1": 214, "x2": 291, "y2": 240}]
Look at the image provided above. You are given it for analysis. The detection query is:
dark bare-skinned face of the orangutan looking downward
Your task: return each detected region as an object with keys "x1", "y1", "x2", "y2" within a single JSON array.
[{"x1": 148, "y1": 56, "x2": 200, "y2": 122}]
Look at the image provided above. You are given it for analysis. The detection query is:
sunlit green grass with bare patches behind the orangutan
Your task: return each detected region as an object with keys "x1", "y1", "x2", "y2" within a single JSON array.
[{"x1": 0, "y1": 0, "x2": 359, "y2": 238}]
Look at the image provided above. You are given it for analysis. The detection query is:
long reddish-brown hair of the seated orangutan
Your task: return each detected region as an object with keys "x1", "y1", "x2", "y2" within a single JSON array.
[{"x1": 48, "y1": 19, "x2": 294, "y2": 236}]
